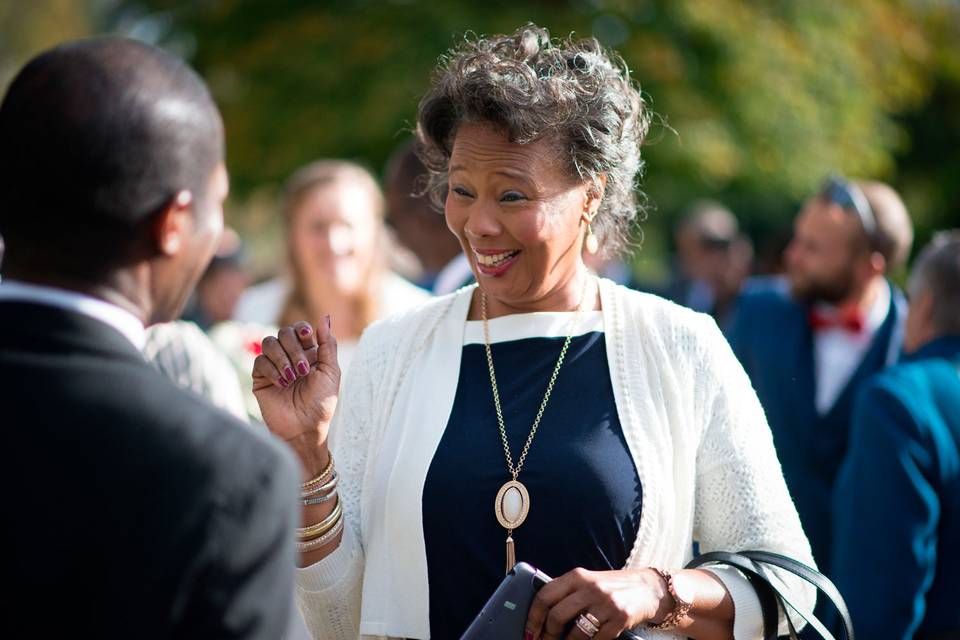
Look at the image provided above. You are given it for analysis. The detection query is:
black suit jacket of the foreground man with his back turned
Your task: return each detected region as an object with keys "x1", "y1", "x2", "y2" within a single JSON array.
[{"x1": 0, "y1": 301, "x2": 297, "y2": 639}]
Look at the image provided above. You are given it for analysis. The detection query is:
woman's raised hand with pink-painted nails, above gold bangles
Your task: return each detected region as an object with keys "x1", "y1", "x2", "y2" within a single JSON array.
[{"x1": 253, "y1": 316, "x2": 340, "y2": 477}]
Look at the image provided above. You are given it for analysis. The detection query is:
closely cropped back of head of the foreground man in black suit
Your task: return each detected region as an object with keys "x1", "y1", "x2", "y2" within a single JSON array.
[{"x1": 0, "y1": 38, "x2": 223, "y2": 283}]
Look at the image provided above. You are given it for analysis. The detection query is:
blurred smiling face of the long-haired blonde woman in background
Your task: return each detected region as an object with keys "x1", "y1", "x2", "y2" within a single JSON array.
[{"x1": 290, "y1": 181, "x2": 380, "y2": 295}]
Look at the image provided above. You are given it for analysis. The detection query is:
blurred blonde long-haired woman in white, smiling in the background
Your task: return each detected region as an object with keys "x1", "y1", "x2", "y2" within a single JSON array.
[{"x1": 234, "y1": 160, "x2": 428, "y2": 368}]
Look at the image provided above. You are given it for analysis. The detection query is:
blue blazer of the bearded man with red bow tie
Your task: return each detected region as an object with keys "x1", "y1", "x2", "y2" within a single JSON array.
[{"x1": 727, "y1": 279, "x2": 907, "y2": 574}]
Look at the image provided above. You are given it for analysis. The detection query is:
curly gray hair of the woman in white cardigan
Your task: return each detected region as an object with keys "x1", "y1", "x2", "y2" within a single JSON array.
[{"x1": 417, "y1": 24, "x2": 650, "y2": 255}]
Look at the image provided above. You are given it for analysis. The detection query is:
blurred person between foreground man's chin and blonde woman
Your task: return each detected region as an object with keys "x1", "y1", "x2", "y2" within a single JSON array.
[{"x1": 183, "y1": 227, "x2": 250, "y2": 331}]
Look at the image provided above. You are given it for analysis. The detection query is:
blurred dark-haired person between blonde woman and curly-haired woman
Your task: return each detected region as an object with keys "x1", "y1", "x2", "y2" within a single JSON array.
[{"x1": 385, "y1": 140, "x2": 474, "y2": 295}]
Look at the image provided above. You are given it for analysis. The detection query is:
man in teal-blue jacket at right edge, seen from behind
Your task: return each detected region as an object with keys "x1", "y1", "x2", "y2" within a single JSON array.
[{"x1": 832, "y1": 230, "x2": 960, "y2": 640}]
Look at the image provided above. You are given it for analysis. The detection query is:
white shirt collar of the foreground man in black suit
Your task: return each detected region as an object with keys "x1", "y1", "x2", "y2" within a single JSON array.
[{"x1": 0, "y1": 279, "x2": 146, "y2": 351}]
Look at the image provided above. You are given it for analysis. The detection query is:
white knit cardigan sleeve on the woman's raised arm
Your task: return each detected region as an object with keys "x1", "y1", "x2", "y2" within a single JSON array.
[{"x1": 294, "y1": 343, "x2": 373, "y2": 640}]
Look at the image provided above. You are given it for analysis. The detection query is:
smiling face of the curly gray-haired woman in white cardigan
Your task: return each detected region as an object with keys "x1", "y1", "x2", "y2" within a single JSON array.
[{"x1": 445, "y1": 123, "x2": 599, "y2": 315}]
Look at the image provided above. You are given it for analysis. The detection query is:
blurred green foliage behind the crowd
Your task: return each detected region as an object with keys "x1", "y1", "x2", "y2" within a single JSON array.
[{"x1": 0, "y1": 0, "x2": 960, "y2": 276}]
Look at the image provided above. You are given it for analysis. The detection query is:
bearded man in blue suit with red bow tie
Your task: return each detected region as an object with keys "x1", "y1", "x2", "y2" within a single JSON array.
[{"x1": 728, "y1": 178, "x2": 913, "y2": 573}]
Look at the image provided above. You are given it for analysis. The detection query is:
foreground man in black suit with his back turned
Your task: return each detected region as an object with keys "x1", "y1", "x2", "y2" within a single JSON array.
[{"x1": 0, "y1": 38, "x2": 297, "y2": 639}]
